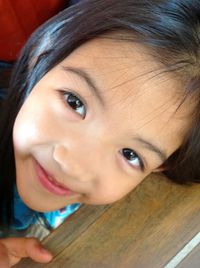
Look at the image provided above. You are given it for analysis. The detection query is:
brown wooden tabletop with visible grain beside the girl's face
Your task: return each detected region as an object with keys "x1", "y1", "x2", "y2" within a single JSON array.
[{"x1": 15, "y1": 175, "x2": 200, "y2": 268}]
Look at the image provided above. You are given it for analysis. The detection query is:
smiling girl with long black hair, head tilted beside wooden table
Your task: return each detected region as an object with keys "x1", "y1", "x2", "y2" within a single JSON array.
[{"x1": 0, "y1": 0, "x2": 200, "y2": 267}]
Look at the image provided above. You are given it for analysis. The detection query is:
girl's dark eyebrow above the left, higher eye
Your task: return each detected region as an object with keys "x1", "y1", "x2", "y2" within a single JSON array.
[{"x1": 62, "y1": 66, "x2": 105, "y2": 106}]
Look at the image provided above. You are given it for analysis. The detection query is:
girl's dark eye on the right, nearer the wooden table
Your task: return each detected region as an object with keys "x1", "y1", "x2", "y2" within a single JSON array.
[{"x1": 122, "y1": 148, "x2": 144, "y2": 171}]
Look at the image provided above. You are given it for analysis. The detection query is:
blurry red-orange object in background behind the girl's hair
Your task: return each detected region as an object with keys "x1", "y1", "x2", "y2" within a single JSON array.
[{"x1": 0, "y1": 0, "x2": 68, "y2": 61}]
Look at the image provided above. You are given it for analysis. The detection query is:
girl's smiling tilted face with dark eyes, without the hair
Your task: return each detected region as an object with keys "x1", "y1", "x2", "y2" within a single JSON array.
[{"x1": 13, "y1": 39, "x2": 191, "y2": 211}]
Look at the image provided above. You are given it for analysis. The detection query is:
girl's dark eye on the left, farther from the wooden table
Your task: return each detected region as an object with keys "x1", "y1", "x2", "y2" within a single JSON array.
[{"x1": 62, "y1": 91, "x2": 86, "y2": 118}]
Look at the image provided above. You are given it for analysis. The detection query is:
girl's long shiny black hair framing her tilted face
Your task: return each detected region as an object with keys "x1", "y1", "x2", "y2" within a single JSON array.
[{"x1": 0, "y1": 0, "x2": 200, "y2": 228}]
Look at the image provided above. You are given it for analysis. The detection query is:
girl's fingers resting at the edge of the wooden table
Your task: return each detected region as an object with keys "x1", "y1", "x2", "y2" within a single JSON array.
[{"x1": 0, "y1": 237, "x2": 52, "y2": 267}]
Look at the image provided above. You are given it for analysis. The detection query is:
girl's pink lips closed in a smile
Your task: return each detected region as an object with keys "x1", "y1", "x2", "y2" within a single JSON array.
[{"x1": 35, "y1": 161, "x2": 75, "y2": 196}]
